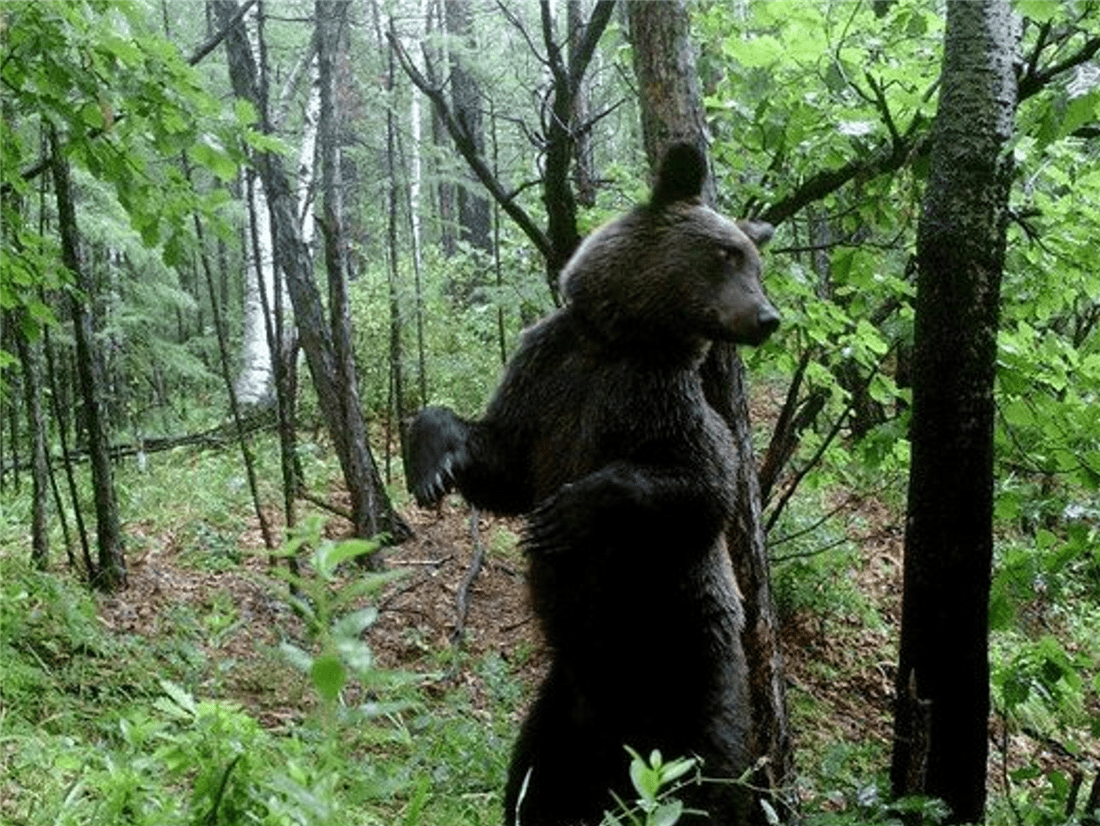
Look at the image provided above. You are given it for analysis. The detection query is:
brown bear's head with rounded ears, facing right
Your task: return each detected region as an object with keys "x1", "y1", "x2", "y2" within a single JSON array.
[{"x1": 561, "y1": 143, "x2": 779, "y2": 353}]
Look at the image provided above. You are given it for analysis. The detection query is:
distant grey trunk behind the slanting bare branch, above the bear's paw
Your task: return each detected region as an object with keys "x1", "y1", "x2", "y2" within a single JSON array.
[{"x1": 443, "y1": 0, "x2": 492, "y2": 252}]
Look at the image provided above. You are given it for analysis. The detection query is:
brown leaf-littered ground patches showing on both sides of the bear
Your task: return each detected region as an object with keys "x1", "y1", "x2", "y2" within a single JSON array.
[{"x1": 90, "y1": 426, "x2": 1086, "y2": 807}]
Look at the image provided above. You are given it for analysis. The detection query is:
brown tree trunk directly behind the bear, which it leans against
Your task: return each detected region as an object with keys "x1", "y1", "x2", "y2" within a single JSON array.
[{"x1": 628, "y1": 0, "x2": 794, "y2": 824}]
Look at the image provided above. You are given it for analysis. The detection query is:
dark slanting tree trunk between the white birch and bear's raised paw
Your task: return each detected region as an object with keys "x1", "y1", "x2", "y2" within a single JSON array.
[{"x1": 212, "y1": 0, "x2": 411, "y2": 542}]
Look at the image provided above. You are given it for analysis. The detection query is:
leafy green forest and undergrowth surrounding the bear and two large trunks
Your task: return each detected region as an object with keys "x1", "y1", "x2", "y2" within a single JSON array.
[{"x1": 0, "y1": 0, "x2": 1100, "y2": 824}]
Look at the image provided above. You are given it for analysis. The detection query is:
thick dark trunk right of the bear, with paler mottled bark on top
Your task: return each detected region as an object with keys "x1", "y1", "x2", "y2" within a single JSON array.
[{"x1": 891, "y1": 0, "x2": 1016, "y2": 823}]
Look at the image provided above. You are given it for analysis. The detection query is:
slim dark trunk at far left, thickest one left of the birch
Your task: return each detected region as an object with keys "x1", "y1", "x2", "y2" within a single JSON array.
[{"x1": 50, "y1": 122, "x2": 127, "y2": 592}]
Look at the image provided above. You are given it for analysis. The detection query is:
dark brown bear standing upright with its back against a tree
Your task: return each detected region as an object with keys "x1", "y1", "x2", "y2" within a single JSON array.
[{"x1": 406, "y1": 144, "x2": 779, "y2": 826}]
